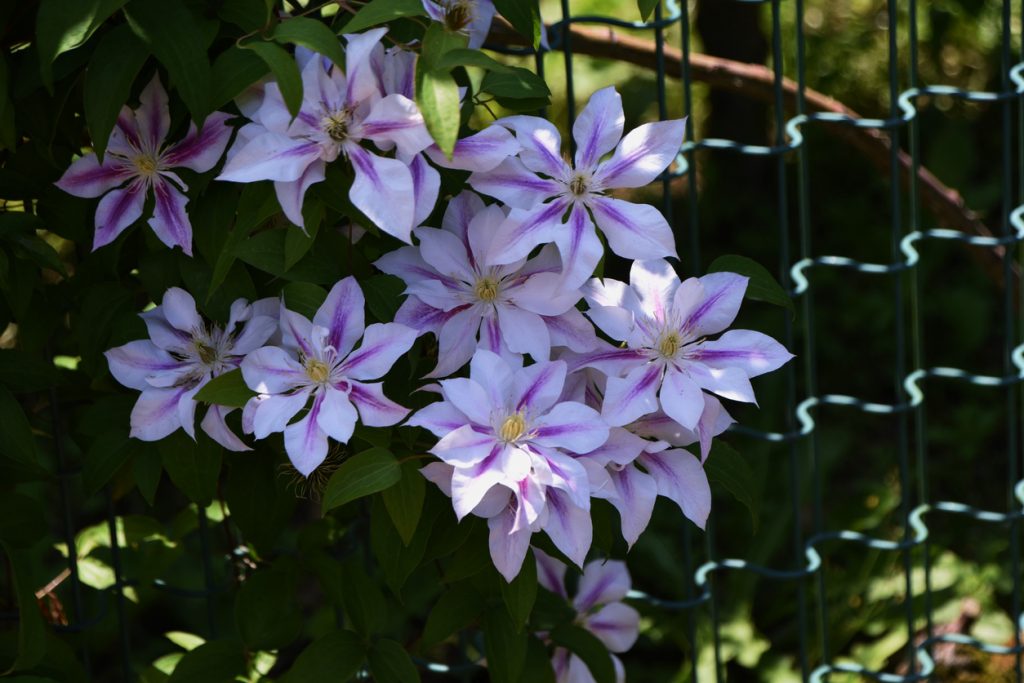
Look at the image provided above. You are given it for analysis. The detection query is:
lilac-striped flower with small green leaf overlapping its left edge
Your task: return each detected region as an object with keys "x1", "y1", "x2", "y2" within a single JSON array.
[{"x1": 242, "y1": 276, "x2": 416, "y2": 476}]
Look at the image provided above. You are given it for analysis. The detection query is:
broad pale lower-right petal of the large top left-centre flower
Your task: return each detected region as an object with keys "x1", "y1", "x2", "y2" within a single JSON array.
[{"x1": 345, "y1": 143, "x2": 415, "y2": 243}]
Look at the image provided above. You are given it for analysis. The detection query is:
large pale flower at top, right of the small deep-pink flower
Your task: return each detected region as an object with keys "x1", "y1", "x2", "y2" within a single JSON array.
[{"x1": 218, "y1": 29, "x2": 436, "y2": 242}]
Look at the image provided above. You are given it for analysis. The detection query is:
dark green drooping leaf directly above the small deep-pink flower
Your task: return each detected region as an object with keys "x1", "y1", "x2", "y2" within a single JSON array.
[{"x1": 82, "y1": 25, "x2": 150, "y2": 161}]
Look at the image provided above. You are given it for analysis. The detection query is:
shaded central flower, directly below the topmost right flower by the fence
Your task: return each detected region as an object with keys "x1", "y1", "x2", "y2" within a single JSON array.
[{"x1": 375, "y1": 191, "x2": 596, "y2": 377}]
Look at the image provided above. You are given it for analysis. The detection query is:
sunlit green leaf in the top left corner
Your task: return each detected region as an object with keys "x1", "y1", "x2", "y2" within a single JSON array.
[{"x1": 36, "y1": 0, "x2": 126, "y2": 88}]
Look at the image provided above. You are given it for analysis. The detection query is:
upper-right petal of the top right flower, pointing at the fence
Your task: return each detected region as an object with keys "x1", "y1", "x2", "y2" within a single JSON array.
[{"x1": 594, "y1": 119, "x2": 686, "y2": 189}]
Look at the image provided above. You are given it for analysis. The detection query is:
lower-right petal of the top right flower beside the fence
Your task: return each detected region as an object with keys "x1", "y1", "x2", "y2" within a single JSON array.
[{"x1": 590, "y1": 197, "x2": 676, "y2": 259}]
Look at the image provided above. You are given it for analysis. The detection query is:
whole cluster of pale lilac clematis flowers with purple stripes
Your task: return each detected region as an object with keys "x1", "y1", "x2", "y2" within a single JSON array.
[{"x1": 83, "y1": 24, "x2": 792, "y2": 589}]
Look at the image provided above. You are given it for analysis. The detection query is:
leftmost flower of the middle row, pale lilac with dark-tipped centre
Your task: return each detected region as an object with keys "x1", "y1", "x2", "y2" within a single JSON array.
[{"x1": 104, "y1": 287, "x2": 278, "y2": 451}]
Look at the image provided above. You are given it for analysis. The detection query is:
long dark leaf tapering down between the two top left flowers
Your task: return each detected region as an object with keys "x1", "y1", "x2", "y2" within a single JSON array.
[{"x1": 125, "y1": 0, "x2": 213, "y2": 124}]
